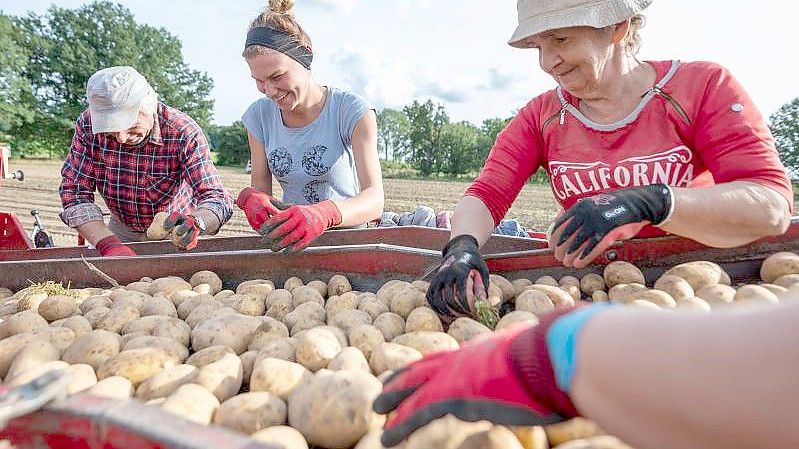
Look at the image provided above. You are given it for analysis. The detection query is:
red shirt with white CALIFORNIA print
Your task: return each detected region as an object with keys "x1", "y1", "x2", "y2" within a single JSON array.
[{"x1": 466, "y1": 61, "x2": 793, "y2": 236}]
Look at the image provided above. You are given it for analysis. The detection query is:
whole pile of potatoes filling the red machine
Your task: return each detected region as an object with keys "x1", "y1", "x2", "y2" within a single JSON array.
[{"x1": 0, "y1": 248, "x2": 799, "y2": 449}]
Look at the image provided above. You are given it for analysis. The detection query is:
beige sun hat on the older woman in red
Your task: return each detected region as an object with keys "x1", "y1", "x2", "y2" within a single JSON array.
[{"x1": 508, "y1": 0, "x2": 652, "y2": 48}]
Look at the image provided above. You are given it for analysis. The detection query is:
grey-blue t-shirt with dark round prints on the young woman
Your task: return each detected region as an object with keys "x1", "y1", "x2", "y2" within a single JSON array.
[{"x1": 242, "y1": 88, "x2": 374, "y2": 204}]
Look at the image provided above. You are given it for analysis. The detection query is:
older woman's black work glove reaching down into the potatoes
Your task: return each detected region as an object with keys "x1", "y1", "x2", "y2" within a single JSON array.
[{"x1": 427, "y1": 235, "x2": 489, "y2": 322}]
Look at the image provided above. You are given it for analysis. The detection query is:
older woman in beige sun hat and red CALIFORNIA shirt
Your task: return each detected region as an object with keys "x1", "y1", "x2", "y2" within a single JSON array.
[{"x1": 427, "y1": 0, "x2": 793, "y2": 318}]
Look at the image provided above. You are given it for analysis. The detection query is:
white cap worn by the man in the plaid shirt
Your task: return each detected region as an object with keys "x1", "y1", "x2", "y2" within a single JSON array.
[{"x1": 86, "y1": 66, "x2": 155, "y2": 134}]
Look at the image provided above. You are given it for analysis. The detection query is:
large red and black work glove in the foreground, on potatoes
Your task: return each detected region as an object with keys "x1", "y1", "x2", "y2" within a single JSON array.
[{"x1": 373, "y1": 307, "x2": 579, "y2": 447}]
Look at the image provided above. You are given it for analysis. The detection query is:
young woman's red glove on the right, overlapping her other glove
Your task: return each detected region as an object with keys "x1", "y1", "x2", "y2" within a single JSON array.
[{"x1": 259, "y1": 200, "x2": 341, "y2": 252}]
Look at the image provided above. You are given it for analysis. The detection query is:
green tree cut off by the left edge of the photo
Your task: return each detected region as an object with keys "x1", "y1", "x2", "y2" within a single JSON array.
[{"x1": 0, "y1": 13, "x2": 34, "y2": 141}]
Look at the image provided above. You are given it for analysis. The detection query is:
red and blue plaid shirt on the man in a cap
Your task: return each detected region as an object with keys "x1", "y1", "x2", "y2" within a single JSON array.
[{"x1": 58, "y1": 102, "x2": 233, "y2": 232}]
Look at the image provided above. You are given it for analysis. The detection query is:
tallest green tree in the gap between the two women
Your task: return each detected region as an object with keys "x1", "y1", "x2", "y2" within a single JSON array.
[{"x1": 402, "y1": 100, "x2": 449, "y2": 176}]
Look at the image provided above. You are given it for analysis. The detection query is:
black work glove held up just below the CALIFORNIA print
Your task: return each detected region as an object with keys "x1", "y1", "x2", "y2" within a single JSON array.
[{"x1": 549, "y1": 184, "x2": 672, "y2": 268}]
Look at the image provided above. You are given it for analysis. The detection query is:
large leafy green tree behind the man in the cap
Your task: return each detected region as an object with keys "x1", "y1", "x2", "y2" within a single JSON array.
[{"x1": 8, "y1": 1, "x2": 213, "y2": 154}]
